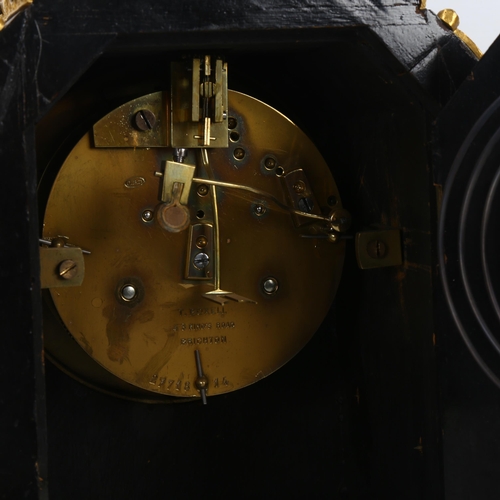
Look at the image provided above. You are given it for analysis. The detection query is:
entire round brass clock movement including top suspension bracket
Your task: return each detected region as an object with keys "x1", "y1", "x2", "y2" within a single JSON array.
[{"x1": 41, "y1": 56, "x2": 350, "y2": 401}]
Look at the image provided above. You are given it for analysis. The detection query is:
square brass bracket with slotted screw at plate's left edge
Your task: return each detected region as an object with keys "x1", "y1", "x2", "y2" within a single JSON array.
[{"x1": 40, "y1": 247, "x2": 85, "y2": 288}]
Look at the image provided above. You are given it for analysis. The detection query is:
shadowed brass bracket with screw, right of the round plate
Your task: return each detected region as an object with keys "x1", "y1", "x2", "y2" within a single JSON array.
[{"x1": 355, "y1": 229, "x2": 403, "y2": 269}]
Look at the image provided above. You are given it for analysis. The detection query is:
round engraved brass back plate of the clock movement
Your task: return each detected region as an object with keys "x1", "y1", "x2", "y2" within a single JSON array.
[{"x1": 43, "y1": 91, "x2": 344, "y2": 397}]
